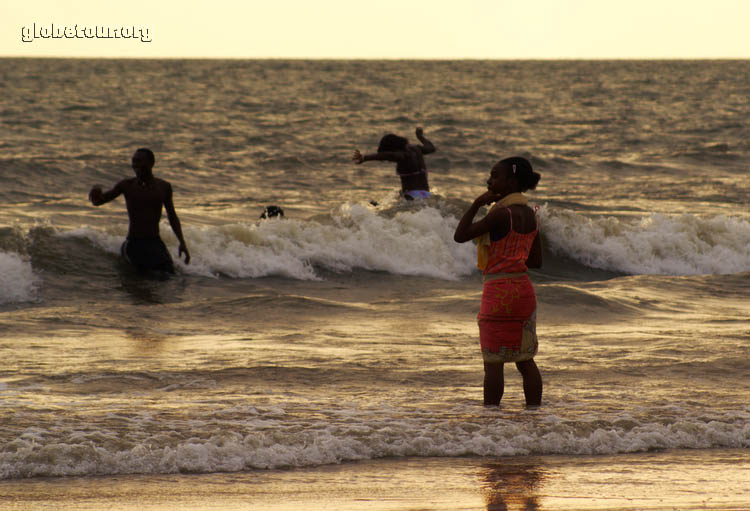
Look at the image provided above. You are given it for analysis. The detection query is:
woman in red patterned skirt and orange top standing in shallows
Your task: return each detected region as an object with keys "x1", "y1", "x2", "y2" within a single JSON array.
[{"x1": 453, "y1": 158, "x2": 542, "y2": 407}]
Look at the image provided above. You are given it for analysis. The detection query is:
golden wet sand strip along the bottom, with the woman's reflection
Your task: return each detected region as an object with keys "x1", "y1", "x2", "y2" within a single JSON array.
[{"x1": 0, "y1": 449, "x2": 750, "y2": 511}]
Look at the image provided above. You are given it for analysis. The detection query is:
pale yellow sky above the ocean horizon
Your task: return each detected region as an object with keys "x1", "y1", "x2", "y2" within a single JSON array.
[{"x1": 0, "y1": 0, "x2": 750, "y2": 59}]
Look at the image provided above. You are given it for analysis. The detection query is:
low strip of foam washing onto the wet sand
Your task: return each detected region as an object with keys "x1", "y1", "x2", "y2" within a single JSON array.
[{"x1": 0, "y1": 409, "x2": 750, "y2": 479}]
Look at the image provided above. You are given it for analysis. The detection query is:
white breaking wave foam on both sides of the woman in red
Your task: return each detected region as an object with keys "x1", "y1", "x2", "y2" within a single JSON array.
[{"x1": 62, "y1": 204, "x2": 750, "y2": 280}]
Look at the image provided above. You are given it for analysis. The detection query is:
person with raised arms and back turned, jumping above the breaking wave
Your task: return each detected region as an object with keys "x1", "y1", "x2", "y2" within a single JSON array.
[{"x1": 352, "y1": 127, "x2": 435, "y2": 200}]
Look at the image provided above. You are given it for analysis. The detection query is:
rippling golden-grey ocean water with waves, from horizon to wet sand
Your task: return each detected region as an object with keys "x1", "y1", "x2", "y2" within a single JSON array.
[{"x1": 0, "y1": 59, "x2": 750, "y2": 480}]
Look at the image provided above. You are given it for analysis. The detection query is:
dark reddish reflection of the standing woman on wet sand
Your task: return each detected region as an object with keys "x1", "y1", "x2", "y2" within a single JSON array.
[{"x1": 479, "y1": 459, "x2": 547, "y2": 511}]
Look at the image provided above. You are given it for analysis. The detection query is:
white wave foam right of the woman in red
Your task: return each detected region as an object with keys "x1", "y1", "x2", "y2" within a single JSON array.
[{"x1": 541, "y1": 207, "x2": 750, "y2": 275}]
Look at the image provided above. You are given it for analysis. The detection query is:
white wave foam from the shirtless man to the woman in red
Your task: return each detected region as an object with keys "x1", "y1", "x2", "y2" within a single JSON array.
[{"x1": 72, "y1": 204, "x2": 482, "y2": 280}]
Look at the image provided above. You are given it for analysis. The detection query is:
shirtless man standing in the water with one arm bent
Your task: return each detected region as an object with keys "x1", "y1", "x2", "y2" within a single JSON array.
[{"x1": 89, "y1": 148, "x2": 190, "y2": 273}]
